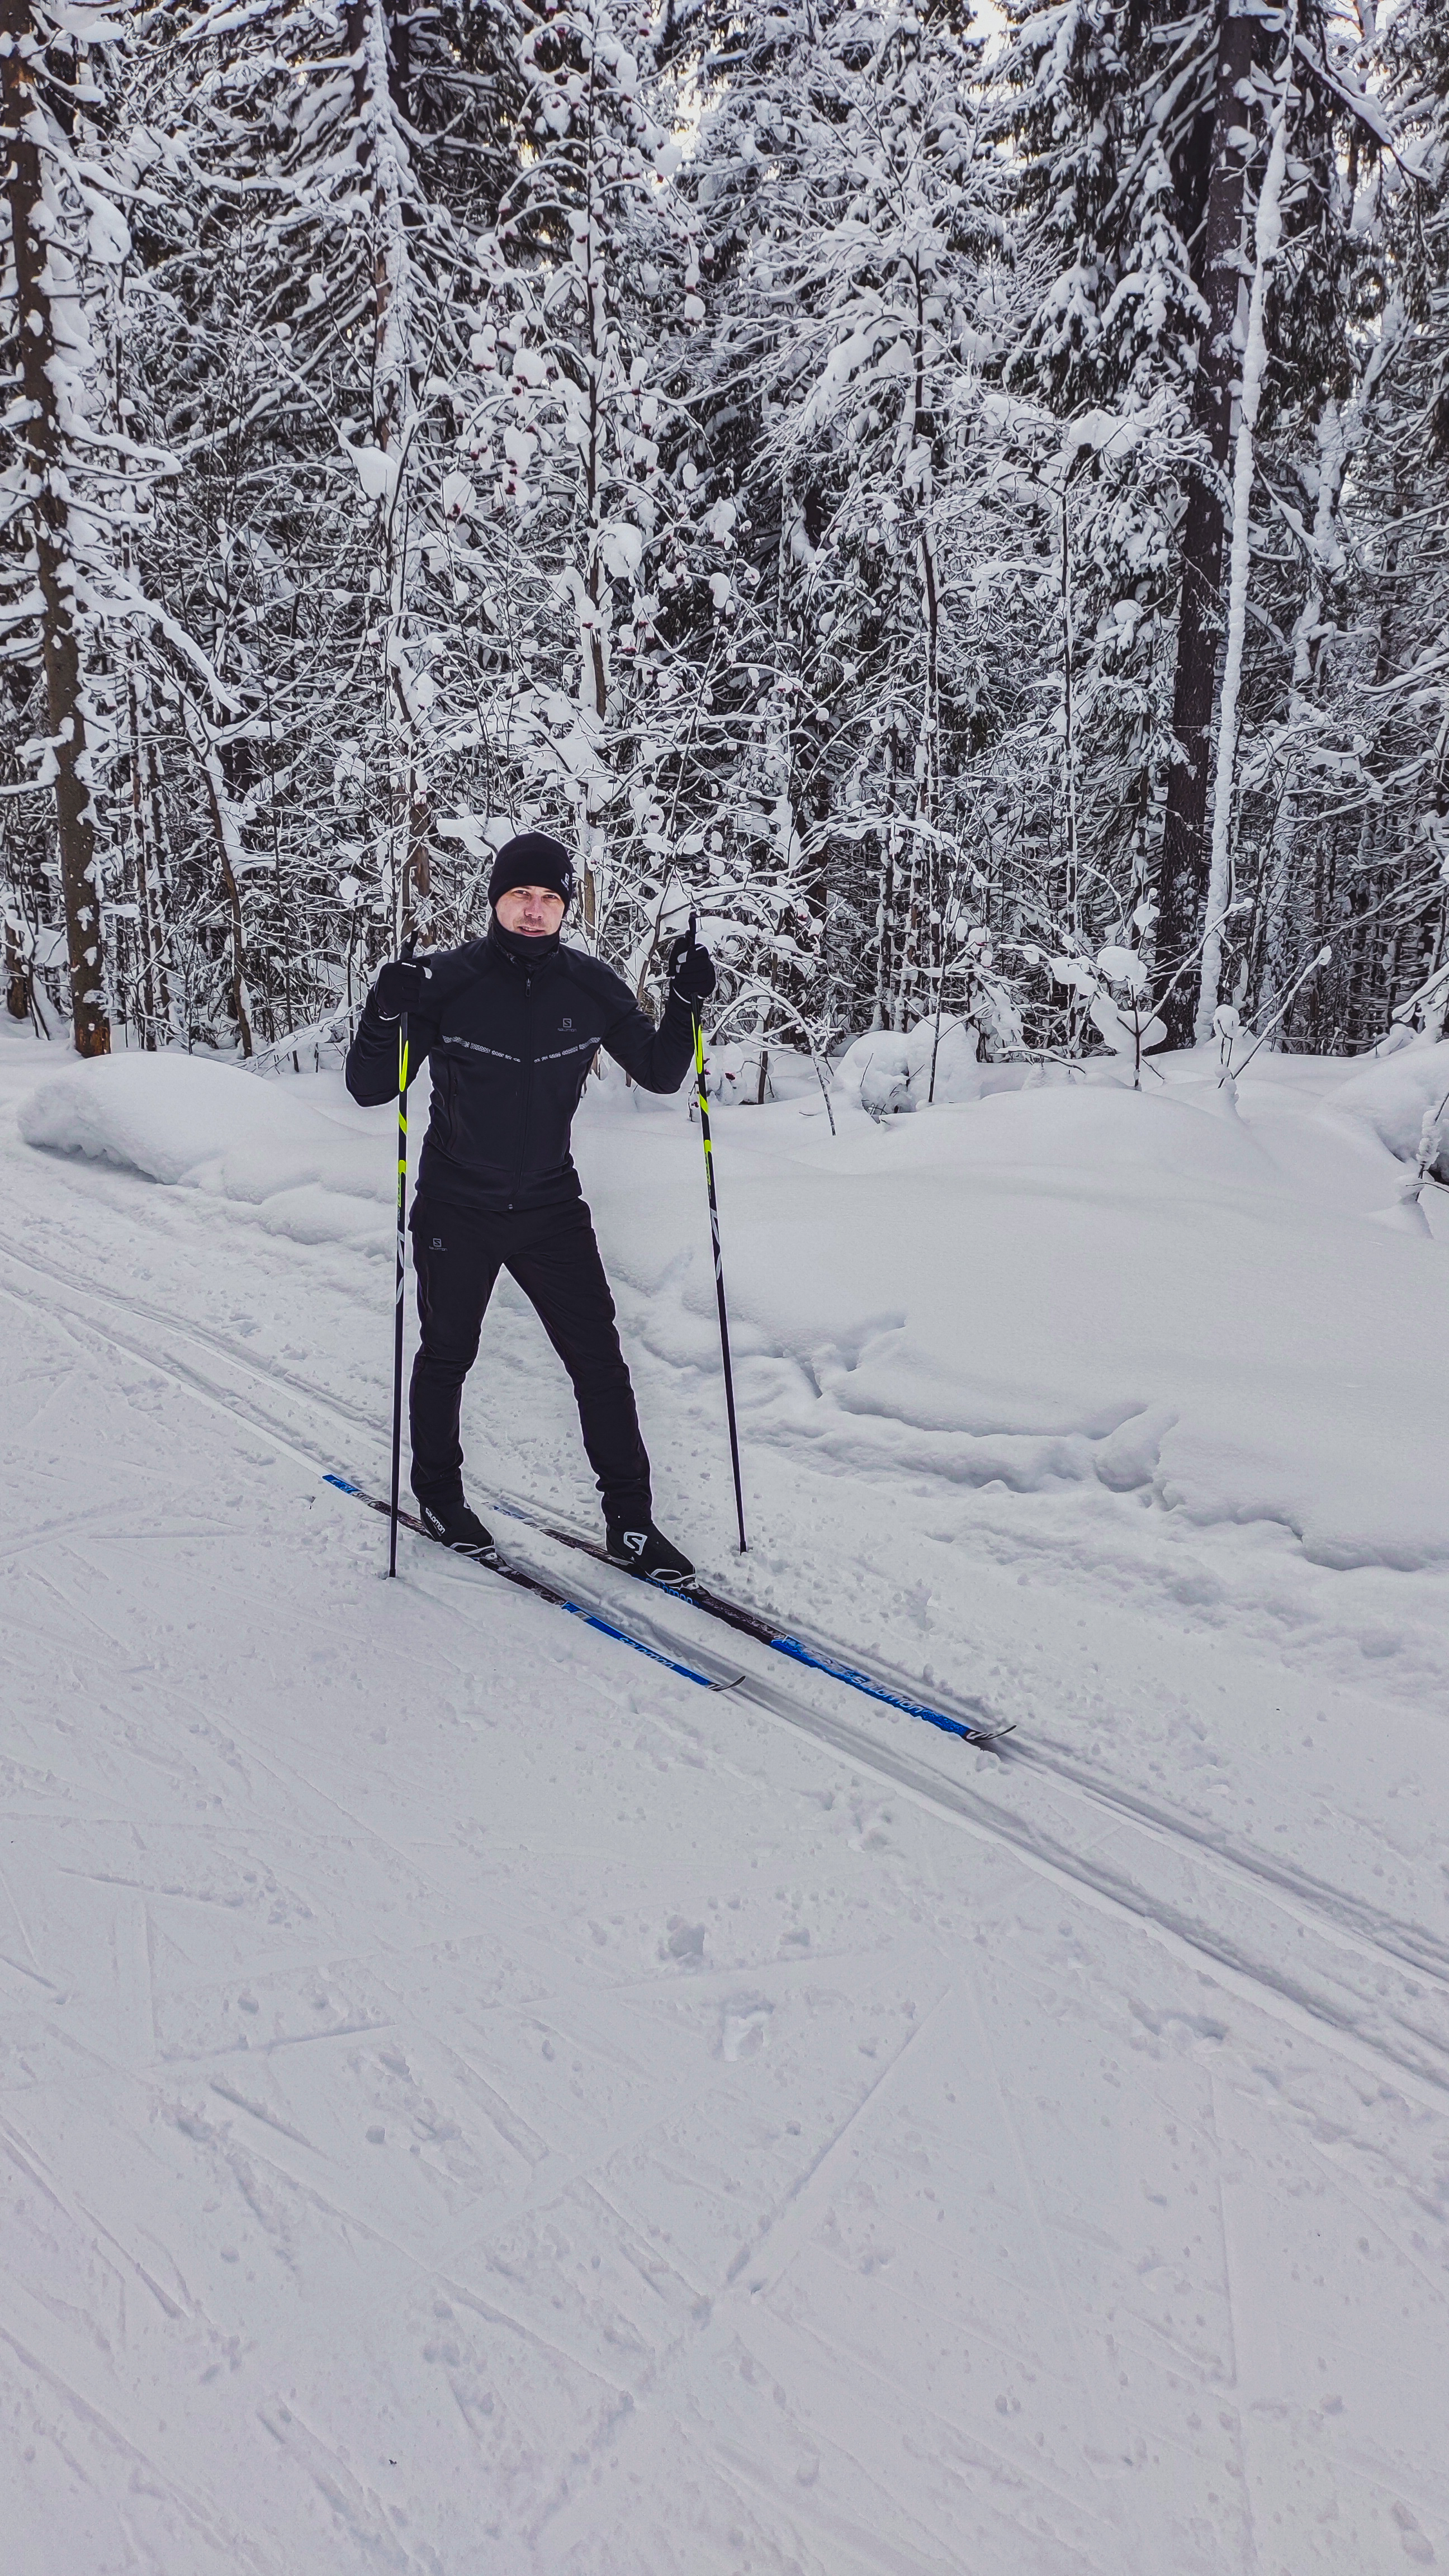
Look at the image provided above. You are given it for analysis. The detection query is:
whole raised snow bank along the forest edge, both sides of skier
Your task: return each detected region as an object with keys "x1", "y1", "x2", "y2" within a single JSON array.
[{"x1": 21, "y1": 1038, "x2": 1449, "y2": 1569}]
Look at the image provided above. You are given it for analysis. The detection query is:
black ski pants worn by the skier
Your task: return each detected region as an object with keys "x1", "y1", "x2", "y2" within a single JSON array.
[{"x1": 410, "y1": 1195, "x2": 650, "y2": 1522}]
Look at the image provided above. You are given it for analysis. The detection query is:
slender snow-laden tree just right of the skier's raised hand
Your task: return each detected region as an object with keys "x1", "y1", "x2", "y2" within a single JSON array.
[{"x1": 670, "y1": 8, "x2": 1021, "y2": 1028}]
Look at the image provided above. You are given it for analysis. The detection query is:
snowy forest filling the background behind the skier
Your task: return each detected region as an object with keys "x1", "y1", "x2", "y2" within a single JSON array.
[{"x1": 0, "y1": 0, "x2": 1449, "y2": 1066}]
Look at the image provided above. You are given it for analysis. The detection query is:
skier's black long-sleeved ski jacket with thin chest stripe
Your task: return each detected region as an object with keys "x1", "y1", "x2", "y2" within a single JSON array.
[{"x1": 345, "y1": 927, "x2": 694, "y2": 1216}]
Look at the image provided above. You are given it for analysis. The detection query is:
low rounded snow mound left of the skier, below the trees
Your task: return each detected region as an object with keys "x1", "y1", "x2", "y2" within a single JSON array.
[{"x1": 18, "y1": 1056, "x2": 395, "y2": 1242}]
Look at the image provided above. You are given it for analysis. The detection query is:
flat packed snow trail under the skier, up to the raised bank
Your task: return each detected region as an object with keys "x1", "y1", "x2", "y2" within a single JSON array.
[{"x1": 0, "y1": 1030, "x2": 1449, "y2": 2576}]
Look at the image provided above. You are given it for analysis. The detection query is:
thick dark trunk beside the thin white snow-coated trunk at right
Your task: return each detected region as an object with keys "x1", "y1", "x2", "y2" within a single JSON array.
[{"x1": 1158, "y1": 0, "x2": 1258, "y2": 1046}]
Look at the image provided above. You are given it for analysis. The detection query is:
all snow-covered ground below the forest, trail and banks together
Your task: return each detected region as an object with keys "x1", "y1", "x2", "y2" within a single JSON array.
[{"x1": 0, "y1": 1010, "x2": 1449, "y2": 2576}]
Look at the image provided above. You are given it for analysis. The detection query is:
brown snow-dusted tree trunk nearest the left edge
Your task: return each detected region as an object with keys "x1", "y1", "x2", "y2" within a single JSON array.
[{"x1": 0, "y1": 0, "x2": 111, "y2": 1056}]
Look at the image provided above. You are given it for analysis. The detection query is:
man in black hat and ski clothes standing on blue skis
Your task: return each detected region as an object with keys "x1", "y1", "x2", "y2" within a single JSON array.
[{"x1": 348, "y1": 832, "x2": 714, "y2": 1581}]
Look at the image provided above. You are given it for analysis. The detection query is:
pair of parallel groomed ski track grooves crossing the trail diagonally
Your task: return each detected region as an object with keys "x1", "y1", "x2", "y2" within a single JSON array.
[{"x1": 0, "y1": 1215, "x2": 1449, "y2": 2110}]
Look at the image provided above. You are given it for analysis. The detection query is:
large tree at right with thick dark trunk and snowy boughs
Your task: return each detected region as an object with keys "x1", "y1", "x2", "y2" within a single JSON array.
[{"x1": 990, "y1": 0, "x2": 1382, "y2": 1038}]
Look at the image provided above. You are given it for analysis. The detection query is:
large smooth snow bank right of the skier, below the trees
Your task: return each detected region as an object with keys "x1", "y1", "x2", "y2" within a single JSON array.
[{"x1": 580, "y1": 1085, "x2": 1449, "y2": 1569}]
